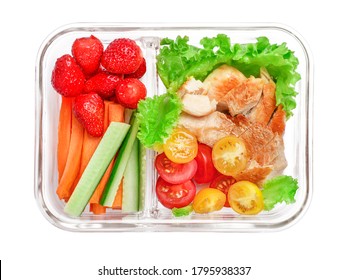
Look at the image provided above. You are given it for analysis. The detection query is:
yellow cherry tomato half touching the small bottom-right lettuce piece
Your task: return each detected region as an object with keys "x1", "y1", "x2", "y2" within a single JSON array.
[{"x1": 227, "y1": 181, "x2": 264, "y2": 215}]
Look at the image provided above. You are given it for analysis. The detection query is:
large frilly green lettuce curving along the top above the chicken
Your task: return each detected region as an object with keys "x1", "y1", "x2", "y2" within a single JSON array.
[{"x1": 157, "y1": 34, "x2": 301, "y2": 117}]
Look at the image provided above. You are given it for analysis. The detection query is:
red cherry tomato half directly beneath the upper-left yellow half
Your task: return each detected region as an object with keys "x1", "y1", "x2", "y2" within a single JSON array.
[{"x1": 155, "y1": 153, "x2": 197, "y2": 184}]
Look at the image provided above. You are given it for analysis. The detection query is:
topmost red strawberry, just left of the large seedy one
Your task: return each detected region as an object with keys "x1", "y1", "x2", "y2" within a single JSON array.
[{"x1": 71, "y1": 35, "x2": 104, "y2": 75}]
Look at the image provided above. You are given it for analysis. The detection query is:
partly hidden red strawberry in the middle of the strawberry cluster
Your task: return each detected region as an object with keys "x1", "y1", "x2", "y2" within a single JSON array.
[{"x1": 84, "y1": 72, "x2": 122, "y2": 99}]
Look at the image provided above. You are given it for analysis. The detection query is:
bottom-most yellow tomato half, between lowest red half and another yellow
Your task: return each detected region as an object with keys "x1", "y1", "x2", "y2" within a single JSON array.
[{"x1": 192, "y1": 188, "x2": 226, "y2": 214}]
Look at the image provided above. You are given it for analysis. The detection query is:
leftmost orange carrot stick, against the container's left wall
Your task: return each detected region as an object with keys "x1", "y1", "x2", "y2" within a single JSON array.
[{"x1": 57, "y1": 96, "x2": 73, "y2": 182}]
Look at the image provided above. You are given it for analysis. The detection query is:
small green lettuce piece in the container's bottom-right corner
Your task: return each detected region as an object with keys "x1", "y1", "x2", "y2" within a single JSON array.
[{"x1": 262, "y1": 175, "x2": 298, "y2": 211}]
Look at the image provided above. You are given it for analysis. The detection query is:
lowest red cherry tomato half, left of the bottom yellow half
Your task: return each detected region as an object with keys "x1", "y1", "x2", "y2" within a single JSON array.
[{"x1": 156, "y1": 177, "x2": 196, "y2": 209}]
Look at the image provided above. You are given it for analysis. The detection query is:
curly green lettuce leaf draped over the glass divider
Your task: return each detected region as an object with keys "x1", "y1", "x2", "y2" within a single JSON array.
[{"x1": 136, "y1": 92, "x2": 182, "y2": 148}]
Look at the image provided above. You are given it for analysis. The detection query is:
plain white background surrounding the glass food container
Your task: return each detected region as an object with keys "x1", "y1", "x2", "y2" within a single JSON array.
[{"x1": 0, "y1": 0, "x2": 348, "y2": 280}]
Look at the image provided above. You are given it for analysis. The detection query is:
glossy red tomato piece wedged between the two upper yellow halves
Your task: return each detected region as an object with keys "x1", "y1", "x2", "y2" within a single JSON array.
[{"x1": 193, "y1": 143, "x2": 217, "y2": 184}]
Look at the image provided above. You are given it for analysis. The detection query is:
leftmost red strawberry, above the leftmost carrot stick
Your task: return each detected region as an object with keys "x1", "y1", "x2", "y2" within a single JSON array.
[{"x1": 51, "y1": 54, "x2": 85, "y2": 97}]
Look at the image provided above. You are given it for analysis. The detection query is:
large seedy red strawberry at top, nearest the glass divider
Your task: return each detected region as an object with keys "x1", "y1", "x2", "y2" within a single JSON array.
[{"x1": 101, "y1": 38, "x2": 143, "y2": 74}]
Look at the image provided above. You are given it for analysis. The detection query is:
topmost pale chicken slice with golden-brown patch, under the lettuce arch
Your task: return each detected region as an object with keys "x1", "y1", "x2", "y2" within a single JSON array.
[{"x1": 203, "y1": 65, "x2": 246, "y2": 109}]
